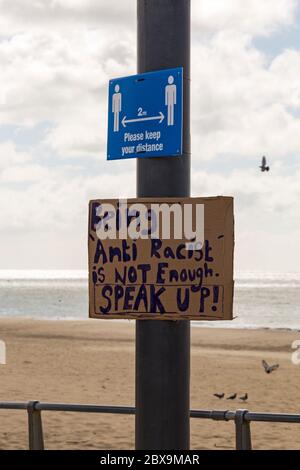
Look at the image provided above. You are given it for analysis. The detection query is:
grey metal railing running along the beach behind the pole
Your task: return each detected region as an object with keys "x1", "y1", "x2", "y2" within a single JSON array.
[{"x1": 0, "y1": 401, "x2": 300, "y2": 450}]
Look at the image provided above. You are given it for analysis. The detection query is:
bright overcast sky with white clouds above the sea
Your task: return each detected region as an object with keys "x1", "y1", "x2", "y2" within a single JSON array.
[{"x1": 0, "y1": 0, "x2": 300, "y2": 272}]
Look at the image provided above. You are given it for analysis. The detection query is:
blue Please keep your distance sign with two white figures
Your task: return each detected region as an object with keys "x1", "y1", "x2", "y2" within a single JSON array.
[{"x1": 107, "y1": 68, "x2": 183, "y2": 160}]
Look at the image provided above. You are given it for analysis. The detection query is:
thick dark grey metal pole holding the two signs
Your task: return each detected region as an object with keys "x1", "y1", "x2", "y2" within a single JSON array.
[{"x1": 136, "y1": 0, "x2": 191, "y2": 450}]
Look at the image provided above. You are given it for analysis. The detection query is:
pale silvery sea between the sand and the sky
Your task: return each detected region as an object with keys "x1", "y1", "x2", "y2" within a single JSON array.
[{"x1": 0, "y1": 270, "x2": 300, "y2": 331}]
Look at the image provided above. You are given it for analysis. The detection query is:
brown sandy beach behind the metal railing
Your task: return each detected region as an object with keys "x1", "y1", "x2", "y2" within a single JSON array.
[{"x1": 0, "y1": 318, "x2": 300, "y2": 449}]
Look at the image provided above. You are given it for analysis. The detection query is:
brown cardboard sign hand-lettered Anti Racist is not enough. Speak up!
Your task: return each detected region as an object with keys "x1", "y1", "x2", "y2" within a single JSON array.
[{"x1": 88, "y1": 197, "x2": 234, "y2": 320}]
